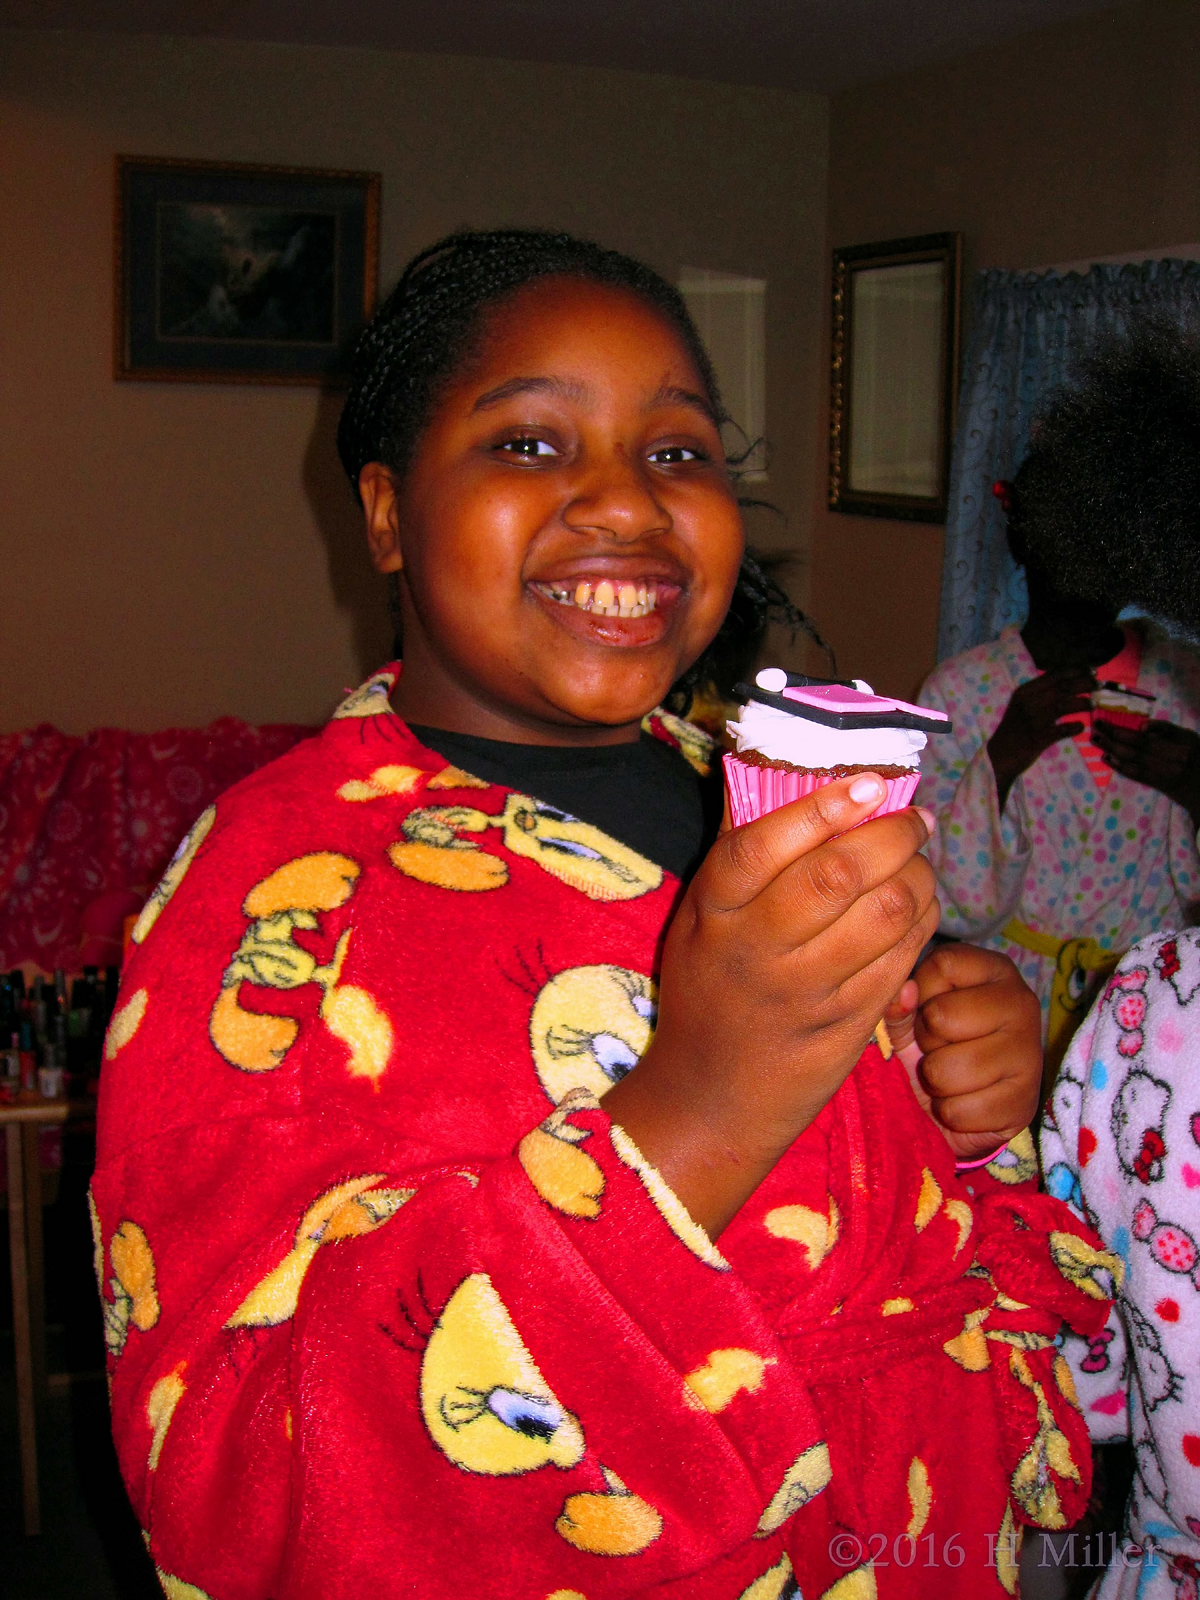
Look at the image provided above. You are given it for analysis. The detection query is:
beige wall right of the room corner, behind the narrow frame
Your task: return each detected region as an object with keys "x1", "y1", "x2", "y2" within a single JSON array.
[{"x1": 811, "y1": 0, "x2": 1200, "y2": 693}]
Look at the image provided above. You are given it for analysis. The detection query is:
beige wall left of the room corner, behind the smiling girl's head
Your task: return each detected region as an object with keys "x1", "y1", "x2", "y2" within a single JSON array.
[{"x1": 0, "y1": 32, "x2": 827, "y2": 731}]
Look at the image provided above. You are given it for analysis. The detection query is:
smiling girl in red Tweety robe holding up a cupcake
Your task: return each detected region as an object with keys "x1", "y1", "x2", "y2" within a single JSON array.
[{"x1": 93, "y1": 232, "x2": 1109, "y2": 1600}]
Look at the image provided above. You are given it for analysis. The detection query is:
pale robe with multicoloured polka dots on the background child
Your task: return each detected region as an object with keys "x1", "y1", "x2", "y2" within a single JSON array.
[{"x1": 915, "y1": 627, "x2": 1200, "y2": 1014}]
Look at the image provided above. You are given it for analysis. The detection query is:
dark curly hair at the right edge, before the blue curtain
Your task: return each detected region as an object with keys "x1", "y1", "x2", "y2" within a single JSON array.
[{"x1": 1008, "y1": 317, "x2": 1200, "y2": 629}]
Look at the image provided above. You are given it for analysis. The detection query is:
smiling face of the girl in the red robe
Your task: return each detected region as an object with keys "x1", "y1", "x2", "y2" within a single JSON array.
[{"x1": 360, "y1": 278, "x2": 742, "y2": 744}]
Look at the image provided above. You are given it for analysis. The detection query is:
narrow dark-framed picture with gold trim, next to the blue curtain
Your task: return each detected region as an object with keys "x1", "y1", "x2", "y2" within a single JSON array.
[{"x1": 829, "y1": 234, "x2": 963, "y2": 522}]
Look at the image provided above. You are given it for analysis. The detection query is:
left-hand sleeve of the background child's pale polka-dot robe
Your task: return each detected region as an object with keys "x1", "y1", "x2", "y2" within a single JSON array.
[{"x1": 915, "y1": 672, "x2": 1032, "y2": 939}]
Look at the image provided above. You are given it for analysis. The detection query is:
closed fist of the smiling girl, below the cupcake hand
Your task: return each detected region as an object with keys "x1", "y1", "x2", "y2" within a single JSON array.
[{"x1": 883, "y1": 944, "x2": 1042, "y2": 1162}]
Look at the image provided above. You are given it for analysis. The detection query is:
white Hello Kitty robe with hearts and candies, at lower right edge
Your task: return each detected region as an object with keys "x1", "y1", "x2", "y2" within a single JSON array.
[{"x1": 1042, "y1": 930, "x2": 1200, "y2": 1600}]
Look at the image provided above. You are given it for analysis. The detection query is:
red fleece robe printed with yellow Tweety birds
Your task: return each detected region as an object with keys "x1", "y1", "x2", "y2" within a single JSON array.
[{"x1": 93, "y1": 667, "x2": 1112, "y2": 1600}]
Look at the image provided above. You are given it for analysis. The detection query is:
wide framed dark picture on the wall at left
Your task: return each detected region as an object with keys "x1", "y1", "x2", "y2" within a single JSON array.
[{"x1": 114, "y1": 155, "x2": 379, "y2": 384}]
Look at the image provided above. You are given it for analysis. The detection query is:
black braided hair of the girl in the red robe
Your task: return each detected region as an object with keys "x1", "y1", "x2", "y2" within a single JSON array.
[{"x1": 338, "y1": 229, "x2": 827, "y2": 707}]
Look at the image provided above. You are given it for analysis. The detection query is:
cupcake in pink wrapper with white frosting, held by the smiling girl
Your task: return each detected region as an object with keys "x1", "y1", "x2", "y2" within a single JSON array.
[{"x1": 725, "y1": 667, "x2": 950, "y2": 826}]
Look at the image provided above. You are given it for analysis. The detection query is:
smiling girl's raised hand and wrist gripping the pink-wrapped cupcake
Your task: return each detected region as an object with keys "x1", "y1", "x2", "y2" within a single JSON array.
[{"x1": 605, "y1": 773, "x2": 947, "y2": 1237}]
